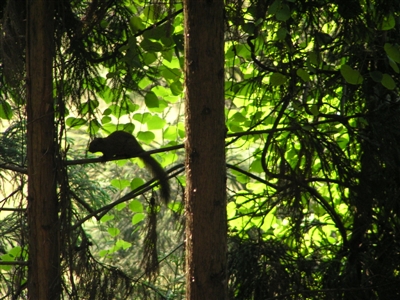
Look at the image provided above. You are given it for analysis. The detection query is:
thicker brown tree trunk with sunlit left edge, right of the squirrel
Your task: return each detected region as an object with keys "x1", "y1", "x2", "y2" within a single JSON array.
[{"x1": 184, "y1": 0, "x2": 227, "y2": 300}]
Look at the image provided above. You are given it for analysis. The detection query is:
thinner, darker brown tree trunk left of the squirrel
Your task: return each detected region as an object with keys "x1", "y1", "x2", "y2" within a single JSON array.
[{"x1": 26, "y1": 0, "x2": 61, "y2": 300}]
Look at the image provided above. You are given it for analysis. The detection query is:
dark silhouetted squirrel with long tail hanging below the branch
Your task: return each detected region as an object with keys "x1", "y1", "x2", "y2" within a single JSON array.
[{"x1": 89, "y1": 131, "x2": 170, "y2": 203}]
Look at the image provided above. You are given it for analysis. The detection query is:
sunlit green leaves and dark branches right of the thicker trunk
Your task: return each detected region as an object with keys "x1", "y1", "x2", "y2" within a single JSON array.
[{"x1": 226, "y1": 1, "x2": 400, "y2": 299}]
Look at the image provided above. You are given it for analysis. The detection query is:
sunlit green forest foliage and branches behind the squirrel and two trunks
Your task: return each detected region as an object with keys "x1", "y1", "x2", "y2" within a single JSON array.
[{"x1": 0, "y1": 0, "x2": 400, "y2": 299}]
